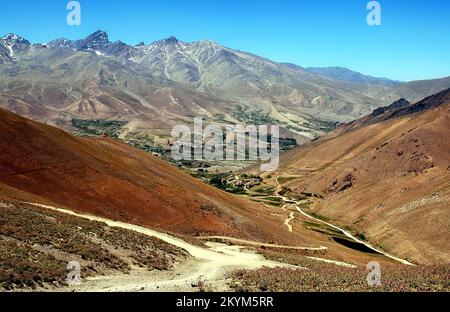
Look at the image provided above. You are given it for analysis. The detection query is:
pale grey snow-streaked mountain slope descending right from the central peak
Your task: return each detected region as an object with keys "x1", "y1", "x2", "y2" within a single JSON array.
[{"x1": 131, "y1": 37, "x2": 388, "y2": 121}]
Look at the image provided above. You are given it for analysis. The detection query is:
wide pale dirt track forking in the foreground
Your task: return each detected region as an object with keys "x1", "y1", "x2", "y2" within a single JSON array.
[{"x1": 23, "y1": 203, "x2": 301, "y2": 292}]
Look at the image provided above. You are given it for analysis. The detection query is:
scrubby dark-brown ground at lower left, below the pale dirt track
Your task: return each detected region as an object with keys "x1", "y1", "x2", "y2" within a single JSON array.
[{"x1": 0, "y1": 199, "x2": 189, "y2": 292}]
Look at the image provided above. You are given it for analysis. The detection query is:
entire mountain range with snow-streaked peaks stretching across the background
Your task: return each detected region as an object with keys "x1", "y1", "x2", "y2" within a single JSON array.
[{"x1": 0, "y1": 31, "x2": 450, "y2": 142}]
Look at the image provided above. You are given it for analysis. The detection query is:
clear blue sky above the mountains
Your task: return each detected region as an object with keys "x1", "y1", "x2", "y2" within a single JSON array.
[{"x1": 0, "y1": 0, "x2": 450, "y2": 81}]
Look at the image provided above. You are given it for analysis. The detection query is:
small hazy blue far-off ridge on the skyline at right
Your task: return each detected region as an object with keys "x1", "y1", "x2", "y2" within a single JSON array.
[{"x1": 305, "y1": 67, "x2": 402, "y2": 87}]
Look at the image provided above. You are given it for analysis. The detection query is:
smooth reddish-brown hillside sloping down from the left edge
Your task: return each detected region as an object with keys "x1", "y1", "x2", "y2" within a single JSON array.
[{"x1": 0, "y1": 109, "x2": 297, "y2": 243}]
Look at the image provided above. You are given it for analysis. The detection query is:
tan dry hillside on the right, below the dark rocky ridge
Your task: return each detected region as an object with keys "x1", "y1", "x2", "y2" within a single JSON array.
[{"x1": 280, "y1": 96, "x2": 450, "y2": 263}]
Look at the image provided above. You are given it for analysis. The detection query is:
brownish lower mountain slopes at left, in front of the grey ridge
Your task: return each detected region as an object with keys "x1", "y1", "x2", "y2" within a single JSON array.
[{"x1": 0, "y1": 39, "x2": 243, "y2": 135}]
